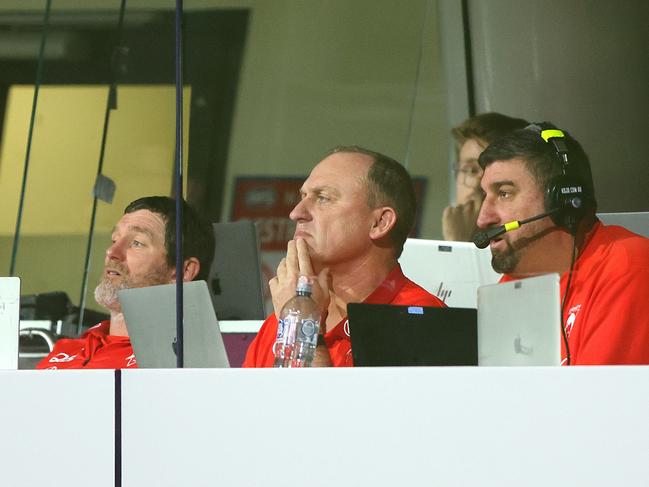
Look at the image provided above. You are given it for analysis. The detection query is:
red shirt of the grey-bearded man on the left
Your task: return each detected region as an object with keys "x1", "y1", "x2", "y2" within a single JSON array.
[{"x1": 36, "y1": 321, "x2": 137, "y2": 369}]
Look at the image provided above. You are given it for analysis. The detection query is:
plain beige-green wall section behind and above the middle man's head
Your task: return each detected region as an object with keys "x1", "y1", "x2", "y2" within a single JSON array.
[{"x1": 224, "y1": 0, "x2": 448, "y2": 237}]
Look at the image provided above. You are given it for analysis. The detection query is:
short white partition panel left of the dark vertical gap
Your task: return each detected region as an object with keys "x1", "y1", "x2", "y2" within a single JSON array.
[{"x1": 0, "y1": 370, "x2": 115, "y2": 487}]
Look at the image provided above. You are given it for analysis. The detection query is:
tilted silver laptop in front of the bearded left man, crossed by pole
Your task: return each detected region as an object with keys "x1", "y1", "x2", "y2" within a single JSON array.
[{"x1": 119, "y1": 281, "x2": 229, "y2": 369}]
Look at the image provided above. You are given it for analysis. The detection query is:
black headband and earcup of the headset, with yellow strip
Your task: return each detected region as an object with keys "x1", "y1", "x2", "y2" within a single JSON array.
[{"x1": 525, "y1": 122, "x2": 593, "y2": 235}]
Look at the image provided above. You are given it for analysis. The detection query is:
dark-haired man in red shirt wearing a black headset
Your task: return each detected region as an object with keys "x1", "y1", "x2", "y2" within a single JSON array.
[{"x1": 476, "y1": 123, "x2": 649, "y2": 365}]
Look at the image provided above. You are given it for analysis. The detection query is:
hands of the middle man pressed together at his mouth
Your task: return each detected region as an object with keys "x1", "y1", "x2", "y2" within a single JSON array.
[{"x1": 268, "y1": 238, "x2": 330, "y2": 320}]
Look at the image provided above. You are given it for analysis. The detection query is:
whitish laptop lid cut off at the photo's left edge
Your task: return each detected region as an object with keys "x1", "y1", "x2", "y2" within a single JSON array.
[{"x1": 0, "y1": 277, "x2": 20, "y2": 370}]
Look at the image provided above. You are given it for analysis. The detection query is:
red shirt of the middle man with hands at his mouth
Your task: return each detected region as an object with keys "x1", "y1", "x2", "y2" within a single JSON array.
[{"x1": 243, "y1": 265, "x2": 445, "y2": 367}]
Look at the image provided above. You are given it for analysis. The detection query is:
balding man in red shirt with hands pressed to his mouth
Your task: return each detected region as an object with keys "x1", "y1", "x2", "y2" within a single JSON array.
[{"x1": 243, "y1": 147, "x2": 443, "y2": 367}]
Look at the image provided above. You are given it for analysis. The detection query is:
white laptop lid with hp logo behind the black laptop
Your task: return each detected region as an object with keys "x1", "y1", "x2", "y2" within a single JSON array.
[{"x1": 399, "y1": 238, "x2": 500, "y2": 309}]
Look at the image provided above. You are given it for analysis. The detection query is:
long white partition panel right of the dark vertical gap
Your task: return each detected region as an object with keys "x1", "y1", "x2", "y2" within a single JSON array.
[{"x1": 122, "y1": 367, "x2": 649, "y2": 487}]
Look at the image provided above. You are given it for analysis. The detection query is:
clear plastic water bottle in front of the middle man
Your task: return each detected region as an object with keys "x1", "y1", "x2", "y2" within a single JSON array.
[{"x1": 273, "y1": 276, "x2": 320, "y2": 367}]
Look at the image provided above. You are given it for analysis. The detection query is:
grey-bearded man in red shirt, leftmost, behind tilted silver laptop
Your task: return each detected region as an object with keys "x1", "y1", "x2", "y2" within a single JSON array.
[{"x1": 36, "y1": 196, "x2": 214, "y2": 369}]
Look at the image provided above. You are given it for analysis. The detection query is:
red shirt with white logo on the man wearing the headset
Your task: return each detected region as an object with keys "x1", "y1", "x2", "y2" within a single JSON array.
[{"x1": 501, "y1": 222, "x2": 649, "y2": 365}]
